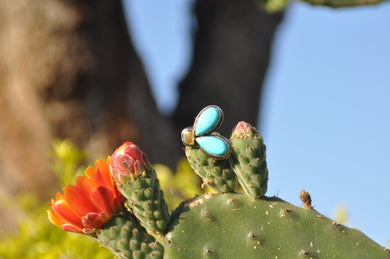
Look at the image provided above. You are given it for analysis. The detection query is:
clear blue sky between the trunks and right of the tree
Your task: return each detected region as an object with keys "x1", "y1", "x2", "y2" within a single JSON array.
[{"x1": 125, "y1": 0, "x2": 390, "y2": 246}]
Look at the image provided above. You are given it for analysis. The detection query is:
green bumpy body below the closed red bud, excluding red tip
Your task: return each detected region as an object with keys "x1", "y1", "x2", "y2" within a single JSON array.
[{"x1": 118, "y1": 169, "x2": 169, "y2": 234}]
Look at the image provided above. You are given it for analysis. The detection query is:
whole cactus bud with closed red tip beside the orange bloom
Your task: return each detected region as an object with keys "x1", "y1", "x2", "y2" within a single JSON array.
[{"x1": 110, "y1": 142, "x2": 169, "y2": 234}]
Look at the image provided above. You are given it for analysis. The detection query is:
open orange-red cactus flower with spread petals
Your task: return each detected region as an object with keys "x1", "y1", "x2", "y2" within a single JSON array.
[{"x1": 47, "y1": 159, "x2": 124, "y2": 235}]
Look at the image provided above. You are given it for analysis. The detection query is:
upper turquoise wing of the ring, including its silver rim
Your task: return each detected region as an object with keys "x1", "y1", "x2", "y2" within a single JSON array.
[{"x1": 194, "y1": 105, "x2": 223, "y2": 136}]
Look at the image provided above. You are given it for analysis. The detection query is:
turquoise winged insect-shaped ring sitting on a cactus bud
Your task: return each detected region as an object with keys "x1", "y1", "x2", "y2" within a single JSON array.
[{"x1": 181, "y1": 105, "x2": 232, "y2": 159}]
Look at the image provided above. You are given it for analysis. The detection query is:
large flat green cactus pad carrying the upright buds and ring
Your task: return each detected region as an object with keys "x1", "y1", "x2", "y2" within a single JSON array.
[{"x1": 164, "y1": 193, "x2": 390, "y2": 258}]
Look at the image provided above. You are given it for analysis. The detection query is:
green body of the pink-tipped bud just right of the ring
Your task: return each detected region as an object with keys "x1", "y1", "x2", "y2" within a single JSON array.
[{"x1": 230, "y1": 124, "x2": 268, "y2": 198}]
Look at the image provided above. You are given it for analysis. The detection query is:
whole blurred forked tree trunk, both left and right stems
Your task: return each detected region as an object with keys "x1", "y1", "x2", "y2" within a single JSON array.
[{"x1": 0, "y1": 0, "x2": 281, "y2": 233}]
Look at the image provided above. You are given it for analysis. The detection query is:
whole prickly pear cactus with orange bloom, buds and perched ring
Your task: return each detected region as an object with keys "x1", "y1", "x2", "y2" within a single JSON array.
[{"x1": 48, "y1": 105, "x2": 390, "y2": 259}]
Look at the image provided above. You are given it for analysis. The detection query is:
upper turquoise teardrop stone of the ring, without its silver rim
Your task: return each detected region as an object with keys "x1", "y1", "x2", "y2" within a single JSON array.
[{"x1": 195, "y1": 107, "x2": 221, "y2": 136}]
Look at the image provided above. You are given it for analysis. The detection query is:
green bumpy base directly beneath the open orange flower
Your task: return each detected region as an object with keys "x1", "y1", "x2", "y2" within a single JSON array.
[{"x1": 97, "y1": 212, "x2": 164, "y2": 259}]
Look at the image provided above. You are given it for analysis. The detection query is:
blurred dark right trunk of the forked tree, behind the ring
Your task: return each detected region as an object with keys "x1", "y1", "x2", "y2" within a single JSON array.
[{"x1": 175, "y1": 0, "x2": 282, "y2": 136}]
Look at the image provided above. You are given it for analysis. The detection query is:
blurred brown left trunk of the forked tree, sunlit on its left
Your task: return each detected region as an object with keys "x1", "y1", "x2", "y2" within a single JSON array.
[{"x1": 0, "y1": 0, "x2": 171, "y2": 235}]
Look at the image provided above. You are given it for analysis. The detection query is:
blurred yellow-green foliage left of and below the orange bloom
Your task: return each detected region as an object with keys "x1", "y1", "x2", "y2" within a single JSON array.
[{"x1": 0, "y1": 140, "x2": 113, "y2": 259}]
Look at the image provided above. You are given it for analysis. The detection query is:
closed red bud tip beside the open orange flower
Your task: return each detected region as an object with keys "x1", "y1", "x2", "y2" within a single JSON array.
[{"x1": 110, "y1": 142, "x2": 151, "y2": 184}]
